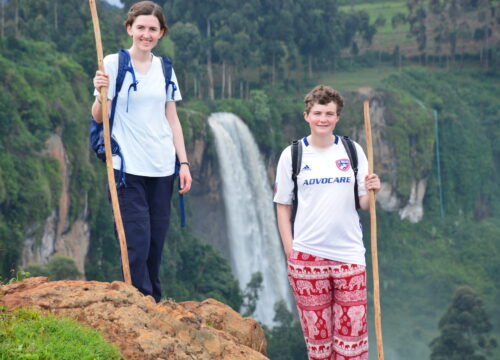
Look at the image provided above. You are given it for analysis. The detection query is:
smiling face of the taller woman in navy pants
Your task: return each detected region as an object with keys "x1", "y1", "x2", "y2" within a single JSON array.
[{"x1": 127, "y1": 15, "x2": 164, "y2": 52}]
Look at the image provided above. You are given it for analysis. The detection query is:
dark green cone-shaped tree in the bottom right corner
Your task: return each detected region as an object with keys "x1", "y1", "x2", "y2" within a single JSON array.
[{"x1": 430, "y1": 286, "x2": 497, "y2": 360}]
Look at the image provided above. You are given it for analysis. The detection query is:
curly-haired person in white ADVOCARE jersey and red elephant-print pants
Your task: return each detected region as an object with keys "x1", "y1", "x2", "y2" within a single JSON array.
[{"x1": 274, "y1": 85, "x2": 380, "y2": 360}]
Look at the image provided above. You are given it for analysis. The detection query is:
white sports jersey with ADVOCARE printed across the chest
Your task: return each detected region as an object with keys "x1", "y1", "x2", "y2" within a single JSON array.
[{"x1": 274, "y1": 136, "x2": 368, "y2": 265}]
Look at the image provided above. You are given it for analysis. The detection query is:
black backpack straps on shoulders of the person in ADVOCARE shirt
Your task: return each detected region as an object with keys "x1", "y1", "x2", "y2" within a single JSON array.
[{"x1": 291, "y1": 136, "x2": 359, "y2": 229}]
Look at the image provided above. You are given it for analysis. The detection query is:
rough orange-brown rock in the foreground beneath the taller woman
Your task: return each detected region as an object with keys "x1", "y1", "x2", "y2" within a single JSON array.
[{"x1": 0, "y1": 277, "x2": 267, "y2": 360}]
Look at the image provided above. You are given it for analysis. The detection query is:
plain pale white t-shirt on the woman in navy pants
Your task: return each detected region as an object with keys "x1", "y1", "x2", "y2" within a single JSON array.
[{"x1": 94, "y1": 54, "x2": 182, "y2": 177}]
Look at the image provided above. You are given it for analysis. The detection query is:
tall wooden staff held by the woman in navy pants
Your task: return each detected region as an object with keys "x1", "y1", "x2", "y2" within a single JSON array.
[{"x1": 89, "y1": 0, "x2": 132, "y2": 284}]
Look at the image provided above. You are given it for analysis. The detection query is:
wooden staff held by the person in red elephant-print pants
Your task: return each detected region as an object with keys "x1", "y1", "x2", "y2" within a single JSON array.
[{"x1": 364, "y1": 101, "x2": 384, "y2": 360}]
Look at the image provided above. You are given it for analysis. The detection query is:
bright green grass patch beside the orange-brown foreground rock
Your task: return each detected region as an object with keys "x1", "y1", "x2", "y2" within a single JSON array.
[{"x1": 0, "y1": 308, "x2": 123, "y2": 360}]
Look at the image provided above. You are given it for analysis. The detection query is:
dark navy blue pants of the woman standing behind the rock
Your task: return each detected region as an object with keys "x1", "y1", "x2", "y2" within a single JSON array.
[{"x1": 115, "y1": 170, "x2": 174, "y2": 302}]
